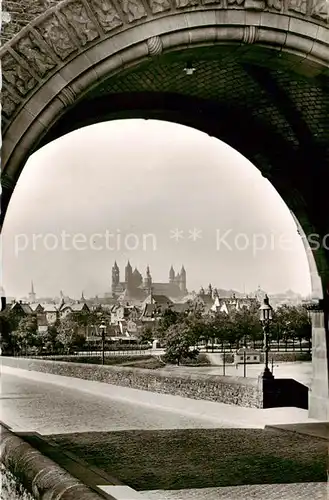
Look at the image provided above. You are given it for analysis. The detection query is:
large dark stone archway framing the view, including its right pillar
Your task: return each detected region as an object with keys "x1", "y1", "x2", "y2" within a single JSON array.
[{"x1": 0, "y1": 0, "x2": 329, "y2": 418}]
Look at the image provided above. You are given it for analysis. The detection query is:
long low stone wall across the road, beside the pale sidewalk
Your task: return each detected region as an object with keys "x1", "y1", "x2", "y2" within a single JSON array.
[{"x1": 2, "y1": 357, "x2": 263, "y2": 408}]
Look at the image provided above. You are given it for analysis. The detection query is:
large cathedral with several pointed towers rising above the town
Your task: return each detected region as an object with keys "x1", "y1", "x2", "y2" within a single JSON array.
[{"x1": 112, "y1": 261, "x2": 188, "y2": 300}]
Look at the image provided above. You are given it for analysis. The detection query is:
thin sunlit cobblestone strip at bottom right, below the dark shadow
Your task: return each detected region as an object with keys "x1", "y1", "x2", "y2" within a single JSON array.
[{"x1": 141, "y1": 483, "x2": 329, "y2": 500}]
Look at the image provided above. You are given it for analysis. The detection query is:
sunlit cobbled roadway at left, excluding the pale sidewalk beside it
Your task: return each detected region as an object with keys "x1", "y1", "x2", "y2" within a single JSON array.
[{"x1": 1, "y1": 372, "x2": 226, "y2": 434}]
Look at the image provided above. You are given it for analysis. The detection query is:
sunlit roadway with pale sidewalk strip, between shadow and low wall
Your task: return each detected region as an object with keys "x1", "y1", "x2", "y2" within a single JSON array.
[{"x1": 1, "y1": 366, "x2": 316, "y2": 434}]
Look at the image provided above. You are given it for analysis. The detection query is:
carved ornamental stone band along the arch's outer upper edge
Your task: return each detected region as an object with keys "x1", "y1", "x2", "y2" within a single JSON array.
[{"x1": 0, "y1": 0, "x2": 328, "y2": 135}]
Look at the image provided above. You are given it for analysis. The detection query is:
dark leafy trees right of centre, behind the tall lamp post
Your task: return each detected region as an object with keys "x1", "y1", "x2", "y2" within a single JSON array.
[{"x1": 137, "y1": 305, "x2": 312, "y2": 364}]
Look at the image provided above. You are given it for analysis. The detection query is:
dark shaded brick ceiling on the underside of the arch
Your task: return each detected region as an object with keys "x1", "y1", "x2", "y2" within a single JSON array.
[{"x1": 41, "y1": 47, "x2": 329, "y2": 204}]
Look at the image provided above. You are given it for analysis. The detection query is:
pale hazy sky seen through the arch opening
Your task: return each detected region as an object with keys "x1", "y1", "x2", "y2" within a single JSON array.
[{"x1": 2, "y1": 120, "x2": 310, "y2": 298}]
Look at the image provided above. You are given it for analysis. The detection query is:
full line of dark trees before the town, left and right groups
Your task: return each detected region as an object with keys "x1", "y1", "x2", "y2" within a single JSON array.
[{"x1": 0, "y1": 298, "x2": 311, "y2": 362}]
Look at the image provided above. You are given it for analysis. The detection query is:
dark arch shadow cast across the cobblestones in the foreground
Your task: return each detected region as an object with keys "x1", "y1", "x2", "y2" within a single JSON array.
[{"x1": 45, "y1": 429, "x2": 328, "y2": 490}]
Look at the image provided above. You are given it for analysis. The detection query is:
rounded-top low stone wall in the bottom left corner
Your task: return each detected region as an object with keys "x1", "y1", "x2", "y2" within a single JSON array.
[{"x1": 0, "y1": 425, "x2": 103, "y2": 500}]
